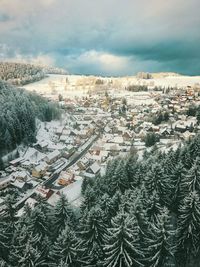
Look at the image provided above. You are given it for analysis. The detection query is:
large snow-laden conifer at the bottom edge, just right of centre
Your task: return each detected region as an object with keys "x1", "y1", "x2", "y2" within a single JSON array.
[{"x1": 103, "y1": 212, "x2": 142, "y2": 267}]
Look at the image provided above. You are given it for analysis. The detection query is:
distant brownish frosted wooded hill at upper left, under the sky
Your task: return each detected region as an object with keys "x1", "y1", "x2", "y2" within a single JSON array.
[{"x1": 0, "y1": 62, "x2": 45, "y2": 85}]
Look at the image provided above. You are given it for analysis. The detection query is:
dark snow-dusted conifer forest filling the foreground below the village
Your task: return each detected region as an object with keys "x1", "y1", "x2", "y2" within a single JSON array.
[{"x1": 0, "y1": 136, "x2": 200, "y2": 267}]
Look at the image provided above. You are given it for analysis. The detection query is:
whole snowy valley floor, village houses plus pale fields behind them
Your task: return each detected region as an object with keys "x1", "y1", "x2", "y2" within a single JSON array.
[{"x1": 0, "y1": 72, "x2": 200, "y2": 216}]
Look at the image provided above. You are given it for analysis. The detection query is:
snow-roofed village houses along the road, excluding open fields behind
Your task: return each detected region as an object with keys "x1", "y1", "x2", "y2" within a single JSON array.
[{"x1": 0, "y1": 81, "x2": 200, "y2": 214}]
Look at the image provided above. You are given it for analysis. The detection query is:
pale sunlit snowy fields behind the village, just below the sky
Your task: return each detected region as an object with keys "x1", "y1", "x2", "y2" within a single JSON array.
[{"x1": 24, "y1": 75, "x2": 200, "y2": 105}]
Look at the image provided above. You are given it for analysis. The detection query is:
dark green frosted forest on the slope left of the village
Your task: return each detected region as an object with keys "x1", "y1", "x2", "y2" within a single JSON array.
[{"x1": 0, "y1": 81, "x2": 60, "y2": 161}]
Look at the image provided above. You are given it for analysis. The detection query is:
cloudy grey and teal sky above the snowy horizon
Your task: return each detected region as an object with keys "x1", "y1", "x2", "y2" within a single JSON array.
[{"x1": 0, "y1": 0, "x2": 200, "y2": 76}]
